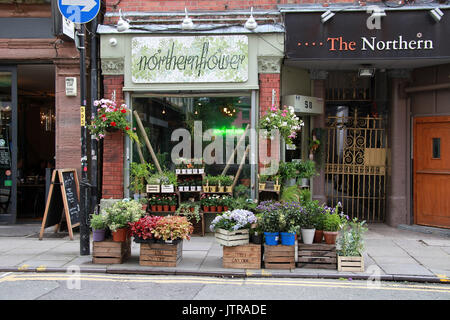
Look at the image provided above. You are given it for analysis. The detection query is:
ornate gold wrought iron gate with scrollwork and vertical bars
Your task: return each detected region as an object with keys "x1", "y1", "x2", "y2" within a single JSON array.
[{"x1": 325, "y1": 110, "x2": 387, "y2": 222}]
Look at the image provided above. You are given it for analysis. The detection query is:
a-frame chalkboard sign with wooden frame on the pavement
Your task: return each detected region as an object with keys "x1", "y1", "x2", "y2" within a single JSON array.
[{"x1": 39, "y1": 169, "x2": 80, "y2": 240}]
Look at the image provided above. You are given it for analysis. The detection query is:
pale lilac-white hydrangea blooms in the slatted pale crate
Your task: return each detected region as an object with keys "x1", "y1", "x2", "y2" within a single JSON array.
[{"x1": 209, "y1": 209, "x2": 257, "y2": 232}]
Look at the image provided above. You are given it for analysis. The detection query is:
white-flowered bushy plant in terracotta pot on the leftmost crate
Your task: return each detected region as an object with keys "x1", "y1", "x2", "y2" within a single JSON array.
[{"x1": 105, "y1": 199, "x2": 145, "y2": 241}]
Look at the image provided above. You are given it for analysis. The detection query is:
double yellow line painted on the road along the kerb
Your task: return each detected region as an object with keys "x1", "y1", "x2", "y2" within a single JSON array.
[{"x1": 0, "y1": 273, "x2": 450, "y2": 298}]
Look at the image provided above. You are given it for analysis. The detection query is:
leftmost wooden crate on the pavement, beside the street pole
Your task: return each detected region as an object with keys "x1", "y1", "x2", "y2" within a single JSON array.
[{"x1": 92, "y1": 238, "x2": 131, "y2": 264}]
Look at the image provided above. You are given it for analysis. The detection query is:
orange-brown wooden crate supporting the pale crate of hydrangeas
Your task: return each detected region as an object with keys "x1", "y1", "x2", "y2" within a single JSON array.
[{"x1": 223, "y1": 243, "x2": 261, "y2": 269}]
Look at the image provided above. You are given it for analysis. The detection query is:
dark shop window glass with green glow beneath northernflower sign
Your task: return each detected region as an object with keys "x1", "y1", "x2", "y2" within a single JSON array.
[{"x1": 132, "y1": 95, "x2": 251, "y2": 191}]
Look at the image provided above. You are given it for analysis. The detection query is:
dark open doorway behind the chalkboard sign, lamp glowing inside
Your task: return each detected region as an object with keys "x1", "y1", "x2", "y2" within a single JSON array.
[{"x1": 17, "y1": 64, "x2": 55, "y2": 220}]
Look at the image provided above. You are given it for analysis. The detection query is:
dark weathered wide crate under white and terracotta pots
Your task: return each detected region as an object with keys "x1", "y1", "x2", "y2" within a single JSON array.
[{"x1": 297, "y1": 242, "x2": 337, "y2": 270}]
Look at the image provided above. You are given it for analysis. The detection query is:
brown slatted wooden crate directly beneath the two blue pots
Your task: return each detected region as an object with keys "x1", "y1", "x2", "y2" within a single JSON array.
[{"x1": 264, "y1": 244, "x2": 295, "y2": 269}]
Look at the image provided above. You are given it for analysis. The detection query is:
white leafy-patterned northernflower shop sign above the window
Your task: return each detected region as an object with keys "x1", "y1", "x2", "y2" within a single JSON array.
[{"x1": 131, "y1": 35, "x2": 248, "y2": 83}]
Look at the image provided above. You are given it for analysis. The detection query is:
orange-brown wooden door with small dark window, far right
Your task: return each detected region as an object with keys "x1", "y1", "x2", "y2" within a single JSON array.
[{"x1": 414, "y1": 116, "x2": 450, "y2": 228}]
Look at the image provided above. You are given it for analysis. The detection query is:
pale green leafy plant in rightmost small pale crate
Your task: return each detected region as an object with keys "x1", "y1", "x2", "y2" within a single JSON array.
[{"x1": 337, "y1": 218, "x2": 368, "y2": 257}]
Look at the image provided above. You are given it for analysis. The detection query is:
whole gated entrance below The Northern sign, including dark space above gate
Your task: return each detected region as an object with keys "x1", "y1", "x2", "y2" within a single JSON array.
[{"x1": 325, "y1": 71, "x2": 388, "y2": 222}]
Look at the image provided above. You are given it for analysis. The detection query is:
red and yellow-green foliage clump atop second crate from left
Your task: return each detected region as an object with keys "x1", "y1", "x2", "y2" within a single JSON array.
[{"x1": 153, "y1": 215, "x2": 194, "y2": 240}]
